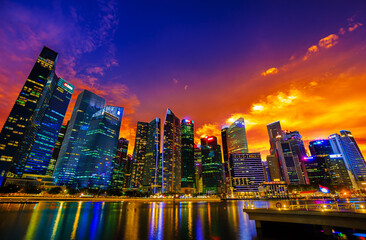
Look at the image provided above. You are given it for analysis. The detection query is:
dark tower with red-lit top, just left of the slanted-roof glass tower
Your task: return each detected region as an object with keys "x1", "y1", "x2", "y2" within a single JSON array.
[{"x1": 201, "y1": 136, "x2": 223, "y2": 194}]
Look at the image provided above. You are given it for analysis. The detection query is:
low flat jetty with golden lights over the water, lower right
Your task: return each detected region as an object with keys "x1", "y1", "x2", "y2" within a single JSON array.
[{"x1": 243, "y1": 202, "x2": 366, "y2": 234}]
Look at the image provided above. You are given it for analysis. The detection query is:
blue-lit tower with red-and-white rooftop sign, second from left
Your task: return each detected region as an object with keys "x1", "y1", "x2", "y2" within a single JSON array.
[{"x1": 11, "y1": 78, "x2": 74, "y2": 177}]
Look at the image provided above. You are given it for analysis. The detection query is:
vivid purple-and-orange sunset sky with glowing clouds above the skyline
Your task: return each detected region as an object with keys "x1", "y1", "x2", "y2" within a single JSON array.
[{"x1": 0, "y1": 0, "x2": 366, "y2": 159}]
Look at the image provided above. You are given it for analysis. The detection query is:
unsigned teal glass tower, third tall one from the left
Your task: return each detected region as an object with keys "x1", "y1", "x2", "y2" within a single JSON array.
[{"x1": 53, "y1": 90, "x2": 105, "y2": 187}]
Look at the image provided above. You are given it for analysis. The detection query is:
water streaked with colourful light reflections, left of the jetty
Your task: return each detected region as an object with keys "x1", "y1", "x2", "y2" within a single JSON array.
[{"x1": 0, "y1": 201, "x2": 256, "y2": 240}]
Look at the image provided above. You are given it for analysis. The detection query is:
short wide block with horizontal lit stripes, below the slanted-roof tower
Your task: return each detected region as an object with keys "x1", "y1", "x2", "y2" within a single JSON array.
[{"x1": 230, "y1": 153, "x2": 265, "y2": 196}]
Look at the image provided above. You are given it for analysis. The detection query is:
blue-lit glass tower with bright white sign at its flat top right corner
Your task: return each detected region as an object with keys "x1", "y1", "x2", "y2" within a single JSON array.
[{"x1": 75, "y1": 106, "x2": 123, "y2": 190}]
